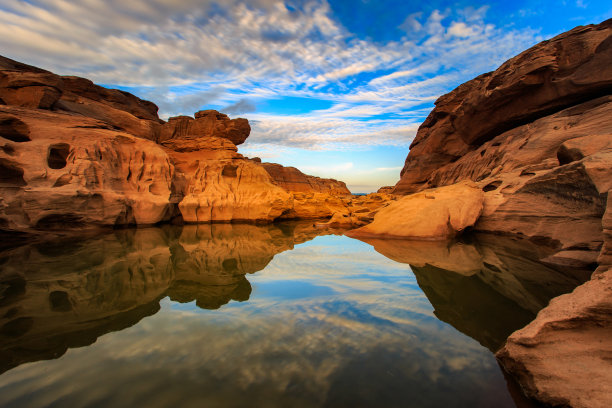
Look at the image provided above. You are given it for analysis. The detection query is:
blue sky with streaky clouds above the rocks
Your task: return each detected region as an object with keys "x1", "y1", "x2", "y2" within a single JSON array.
[{"x1": 0, "y1": 0, "x2": 612, "y2": 193}]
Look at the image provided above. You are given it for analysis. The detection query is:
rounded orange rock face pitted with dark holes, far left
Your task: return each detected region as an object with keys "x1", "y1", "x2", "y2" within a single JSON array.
[{"x1": 0, "y1": 106, "x2": 174, "y2": 230}]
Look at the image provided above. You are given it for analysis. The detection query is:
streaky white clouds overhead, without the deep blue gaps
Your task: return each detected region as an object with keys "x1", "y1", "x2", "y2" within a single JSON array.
[{"x1": 0, "y1": 0, "x2": 536, "y2": 155}]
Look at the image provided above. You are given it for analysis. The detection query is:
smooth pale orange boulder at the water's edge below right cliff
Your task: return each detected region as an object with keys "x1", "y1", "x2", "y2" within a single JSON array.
[{"x1": 347, "y1": 182, "x2": 484, "y2": 240}]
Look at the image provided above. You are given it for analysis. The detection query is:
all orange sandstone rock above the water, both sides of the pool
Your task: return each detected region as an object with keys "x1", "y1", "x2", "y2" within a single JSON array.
[{"x1": 0, "y1": 20, "x2": 612, "y2": 407}]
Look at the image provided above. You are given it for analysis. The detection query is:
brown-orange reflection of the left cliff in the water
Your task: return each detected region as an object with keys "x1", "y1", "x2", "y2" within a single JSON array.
[{"x1": 0, "y1": 223, "x2": 330, "y2": 372}]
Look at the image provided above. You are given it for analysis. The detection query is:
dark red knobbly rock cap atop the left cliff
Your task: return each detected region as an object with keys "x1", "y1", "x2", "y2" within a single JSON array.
[{"x1": 158, "y1": 110, "x2": 251, "y2": 145}]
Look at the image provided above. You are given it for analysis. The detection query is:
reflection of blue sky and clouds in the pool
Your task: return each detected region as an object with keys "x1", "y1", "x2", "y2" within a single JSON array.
[{"x1": 0, "y1": 236, "x2": 511, "y2": 407}]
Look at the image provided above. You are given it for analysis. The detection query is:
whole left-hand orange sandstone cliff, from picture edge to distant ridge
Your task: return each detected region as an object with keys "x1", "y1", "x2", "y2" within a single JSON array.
[{"x1": 0, "y1": 57, "x2": 350, "y2": 232}]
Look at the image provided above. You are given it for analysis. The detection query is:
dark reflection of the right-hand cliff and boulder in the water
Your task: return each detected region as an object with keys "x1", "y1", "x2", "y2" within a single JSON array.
[{"x1": 356, "y1": 234, "x2": 589, "y2": 351}]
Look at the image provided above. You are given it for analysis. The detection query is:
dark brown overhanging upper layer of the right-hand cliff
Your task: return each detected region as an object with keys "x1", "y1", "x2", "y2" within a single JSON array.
[{"x1": 395, "y1": 20, "x2": 612, "y2": 194}]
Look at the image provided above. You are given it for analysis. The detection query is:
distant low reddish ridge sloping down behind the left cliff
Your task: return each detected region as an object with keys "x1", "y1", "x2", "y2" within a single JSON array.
[{"x1": 261, "y1": 163, "x2": 351, "y2": 196}]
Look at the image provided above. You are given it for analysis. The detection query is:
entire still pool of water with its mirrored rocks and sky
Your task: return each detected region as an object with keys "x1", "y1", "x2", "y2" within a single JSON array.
[{"x1": 0, "y1": 223, "x2": 579, "y2": 407}]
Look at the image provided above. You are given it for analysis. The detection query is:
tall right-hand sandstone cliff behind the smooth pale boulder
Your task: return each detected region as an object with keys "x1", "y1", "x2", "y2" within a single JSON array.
[{"x1": 394, "y1": 21, "x2": 612, "y2": 265}]
